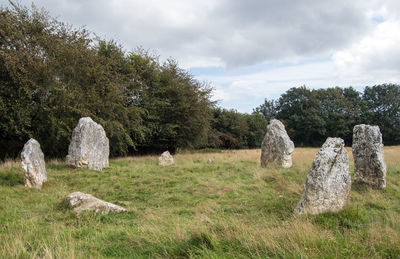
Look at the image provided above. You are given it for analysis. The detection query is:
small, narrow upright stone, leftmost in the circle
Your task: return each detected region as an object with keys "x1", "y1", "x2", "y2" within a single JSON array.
[{"x1": 21, "y1": 138, "x2": 47, "y2": 189}]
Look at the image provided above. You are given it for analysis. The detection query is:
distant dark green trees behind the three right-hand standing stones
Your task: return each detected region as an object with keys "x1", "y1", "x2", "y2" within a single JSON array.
[{"x1": 254, "y1": 84, "x2": 400, "y2": 146}]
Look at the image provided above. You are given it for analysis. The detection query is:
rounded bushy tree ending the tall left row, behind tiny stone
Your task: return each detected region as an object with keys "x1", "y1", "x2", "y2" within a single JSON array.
[{"x1": 128, "y1": 49, "x2": 214, "y2": 152}]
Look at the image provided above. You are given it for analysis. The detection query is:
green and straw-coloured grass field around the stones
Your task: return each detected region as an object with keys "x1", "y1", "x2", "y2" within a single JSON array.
[{"x1": 0, "y1": 147, "x2": 400, "y2": 258}]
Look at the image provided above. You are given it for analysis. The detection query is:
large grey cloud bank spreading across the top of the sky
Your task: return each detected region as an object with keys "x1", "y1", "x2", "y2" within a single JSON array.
[{"x1": 4, "y1": 0, "x2": 369, "y2": 68}]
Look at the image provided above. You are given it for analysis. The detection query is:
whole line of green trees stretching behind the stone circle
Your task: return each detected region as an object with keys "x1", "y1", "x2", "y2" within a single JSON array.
[{"x1": 0, "y1": 1, "x2": 400, "y2": 159}]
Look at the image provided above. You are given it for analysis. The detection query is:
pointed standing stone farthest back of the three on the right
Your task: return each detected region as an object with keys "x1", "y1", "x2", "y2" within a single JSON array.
[{"x1": 261, "y1": 120, "x2": 294, "y2": 168}]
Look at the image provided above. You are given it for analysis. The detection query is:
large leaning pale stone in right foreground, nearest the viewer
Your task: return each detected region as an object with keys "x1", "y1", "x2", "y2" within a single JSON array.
[{"x1": 294, "y1": 138, "x2": 351, "y2": 214}]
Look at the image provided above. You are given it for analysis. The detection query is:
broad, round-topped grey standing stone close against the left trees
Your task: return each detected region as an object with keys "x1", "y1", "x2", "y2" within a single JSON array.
[{"x1": 66, "y1": 117, "x2": 110, "y2": 171}]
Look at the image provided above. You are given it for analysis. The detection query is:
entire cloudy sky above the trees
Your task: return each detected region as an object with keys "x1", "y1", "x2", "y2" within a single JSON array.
[{"x1": 0, "y1": 0, "x2": 400, "y2": 113}]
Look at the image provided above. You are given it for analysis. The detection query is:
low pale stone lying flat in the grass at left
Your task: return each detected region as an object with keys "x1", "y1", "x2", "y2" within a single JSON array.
[{"x1": 65, "y1": 192, "x2": 128, "y2": 215}]
